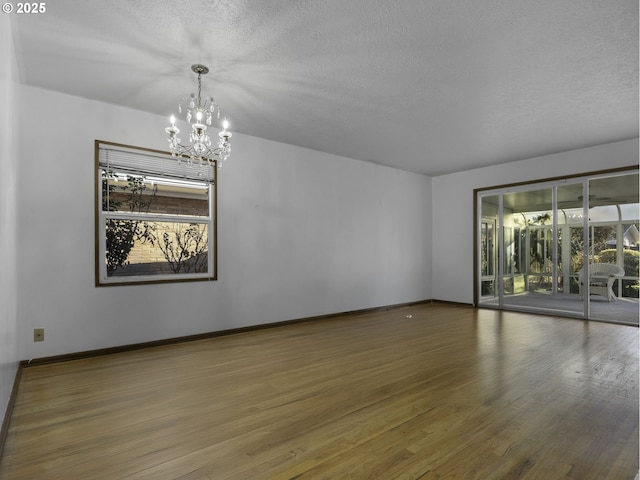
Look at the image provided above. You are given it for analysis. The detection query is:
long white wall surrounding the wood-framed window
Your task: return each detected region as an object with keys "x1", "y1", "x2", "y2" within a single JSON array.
[{"x1": 19, "y1": 86, "x2": 431, "y2": 359}]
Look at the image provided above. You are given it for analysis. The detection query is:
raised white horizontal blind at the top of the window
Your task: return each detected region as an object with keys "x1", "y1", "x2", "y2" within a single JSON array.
[{"x1": 98, "y1": 143, "x2": 215, "y2": 183}]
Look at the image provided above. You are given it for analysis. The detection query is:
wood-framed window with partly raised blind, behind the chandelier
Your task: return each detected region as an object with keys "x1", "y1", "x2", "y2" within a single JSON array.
[{"x1": 95, "y1": 140, "x2": 217, "y2": 285}]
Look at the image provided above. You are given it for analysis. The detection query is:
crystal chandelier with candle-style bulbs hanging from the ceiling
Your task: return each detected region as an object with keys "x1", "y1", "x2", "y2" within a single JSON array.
[{"x1": 164, "y1": 64, "x2": 231, "y2": 167}]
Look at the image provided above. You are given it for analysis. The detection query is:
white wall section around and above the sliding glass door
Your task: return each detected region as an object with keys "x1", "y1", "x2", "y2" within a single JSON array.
[{"x1": 432, "y1": 139, "x2": 638, "y2": 303}]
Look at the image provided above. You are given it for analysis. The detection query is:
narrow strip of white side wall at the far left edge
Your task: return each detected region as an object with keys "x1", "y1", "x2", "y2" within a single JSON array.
[{"x1": 0, "y1": 15, "x2": 19, "y2": 423}]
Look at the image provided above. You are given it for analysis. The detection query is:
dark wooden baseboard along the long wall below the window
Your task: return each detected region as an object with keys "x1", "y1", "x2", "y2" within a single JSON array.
[{"x1": 20, "y1": 299, "x2": 440, "y2": 367}]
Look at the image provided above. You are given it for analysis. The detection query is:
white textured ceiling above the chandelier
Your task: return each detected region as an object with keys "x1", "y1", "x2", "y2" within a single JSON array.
[{"x1": 11, "y1": 0, "x2": 638, "y2": 175}]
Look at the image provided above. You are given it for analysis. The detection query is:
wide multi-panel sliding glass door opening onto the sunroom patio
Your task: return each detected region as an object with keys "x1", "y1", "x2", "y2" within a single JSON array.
[{"x1": 475, "y1": 173, "x2": 640, "y2": 324}]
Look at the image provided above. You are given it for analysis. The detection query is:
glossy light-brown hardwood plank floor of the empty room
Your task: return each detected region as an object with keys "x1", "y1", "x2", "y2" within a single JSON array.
[{"x1": 0, "y1": 304, "x2": 639, "y2": 480}]
